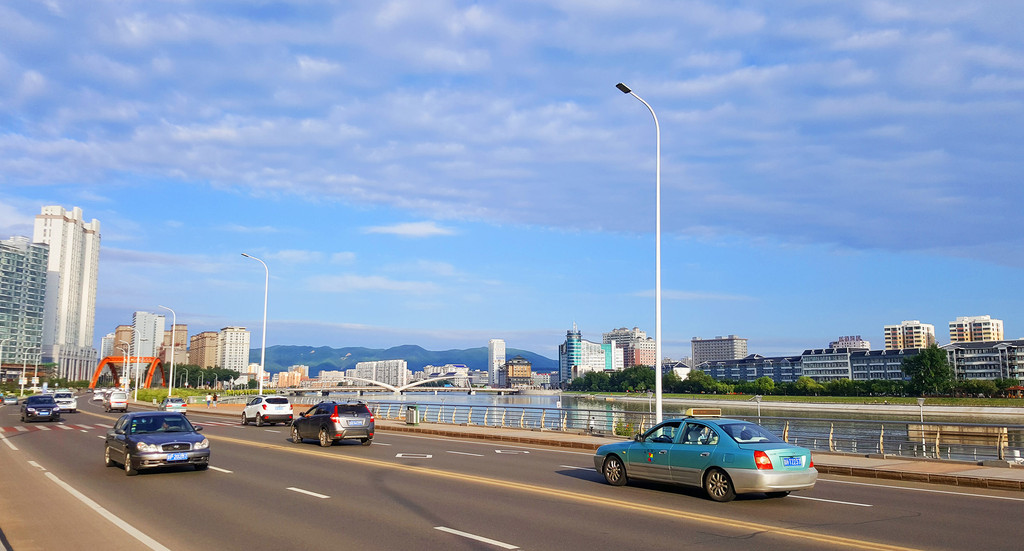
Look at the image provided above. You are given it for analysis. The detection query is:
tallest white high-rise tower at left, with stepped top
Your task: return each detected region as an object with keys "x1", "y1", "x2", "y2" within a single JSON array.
[{"x1": 32, "y1": 206, "x2": 99, "y2": 381}]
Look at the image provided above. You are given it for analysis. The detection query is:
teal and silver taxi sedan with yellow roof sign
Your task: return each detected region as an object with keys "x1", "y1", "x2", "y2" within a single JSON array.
[{"x1": 594, "y1": 409, "x2": 818, "y2": 502}]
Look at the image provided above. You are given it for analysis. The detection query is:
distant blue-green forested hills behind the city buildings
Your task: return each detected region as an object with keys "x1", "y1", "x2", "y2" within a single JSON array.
[{"x1": 249, "y1": 344, "x2": 558, "y2": 377}]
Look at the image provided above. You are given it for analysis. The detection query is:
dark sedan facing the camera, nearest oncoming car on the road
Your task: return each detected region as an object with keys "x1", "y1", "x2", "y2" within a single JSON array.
[{"x1": 103, "y1": 412, "x2": 210, "y2": 476}]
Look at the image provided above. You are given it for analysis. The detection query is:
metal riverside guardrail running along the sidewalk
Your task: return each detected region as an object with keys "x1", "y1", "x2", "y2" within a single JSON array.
[{"x1": 367, "y1": 400, "x2": 1024, "y2": 463}]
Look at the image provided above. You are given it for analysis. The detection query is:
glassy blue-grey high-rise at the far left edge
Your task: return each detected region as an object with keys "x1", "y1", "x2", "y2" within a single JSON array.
[{"x1": 0, "y1": 237, "x2": 49, "y2": 373}]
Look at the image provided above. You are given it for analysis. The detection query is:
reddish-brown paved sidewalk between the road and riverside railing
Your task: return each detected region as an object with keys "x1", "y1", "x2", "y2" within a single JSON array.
[{"x1": 188, "y1": 404, "x2": 1024, "y2": 491}]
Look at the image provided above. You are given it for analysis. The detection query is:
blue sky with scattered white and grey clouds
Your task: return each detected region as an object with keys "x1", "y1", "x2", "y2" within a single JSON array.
[{"x1": 0, "y1": 0, "x2": 1024, "y2": 358}]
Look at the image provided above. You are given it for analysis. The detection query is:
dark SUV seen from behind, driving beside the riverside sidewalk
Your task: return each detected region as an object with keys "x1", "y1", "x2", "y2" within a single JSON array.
[{"x1": 292, "y1": 401, "x2": 374, "y2": 448}]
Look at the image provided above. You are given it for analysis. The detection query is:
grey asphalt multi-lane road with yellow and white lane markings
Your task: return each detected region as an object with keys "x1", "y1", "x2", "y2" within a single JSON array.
[{"x1": 0, "y1": 395, "x2": 1024, "y2": 551}]
